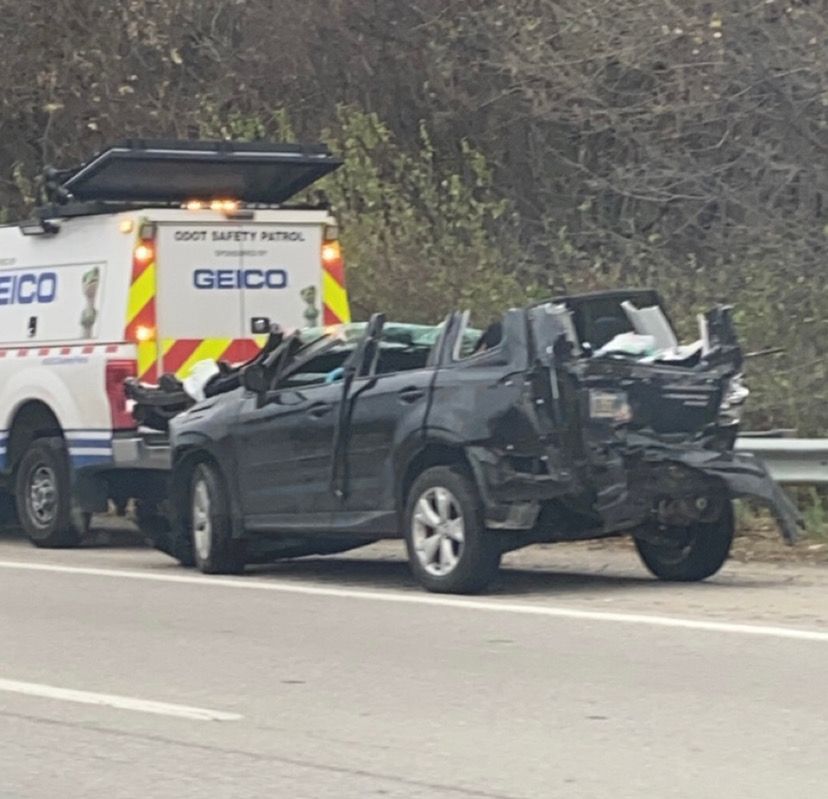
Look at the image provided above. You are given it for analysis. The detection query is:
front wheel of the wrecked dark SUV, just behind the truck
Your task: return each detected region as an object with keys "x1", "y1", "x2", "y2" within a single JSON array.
[{"x1": 187, "y1": 463, "x2": 245, "y2": 574}]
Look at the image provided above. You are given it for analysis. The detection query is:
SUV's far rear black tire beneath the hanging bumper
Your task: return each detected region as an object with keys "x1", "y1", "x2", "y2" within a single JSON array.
[{"x1": 635, "y1": 502, "x2": 735, "y2": 583}]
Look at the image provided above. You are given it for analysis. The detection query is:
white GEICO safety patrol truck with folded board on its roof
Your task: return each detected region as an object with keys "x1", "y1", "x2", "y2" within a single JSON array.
[{"x1": 0, "y1": 140, "x2": 350, "y2": 547}]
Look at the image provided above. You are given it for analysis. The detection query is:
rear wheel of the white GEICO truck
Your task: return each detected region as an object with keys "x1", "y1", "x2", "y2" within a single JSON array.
[{"x1": 15, "y1": 438, "x2": 83, "y2": 548}]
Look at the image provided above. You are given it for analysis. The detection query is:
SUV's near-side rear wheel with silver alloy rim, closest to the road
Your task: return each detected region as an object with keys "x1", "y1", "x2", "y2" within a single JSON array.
[{"x1": 404, "y1": 466, "x2": 501, "y2": 594}]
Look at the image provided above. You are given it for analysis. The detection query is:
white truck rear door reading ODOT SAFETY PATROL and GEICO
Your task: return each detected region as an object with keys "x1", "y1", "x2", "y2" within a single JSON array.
[{"x1": 156, "y1": 221, "x2": 323, "y2": 376}]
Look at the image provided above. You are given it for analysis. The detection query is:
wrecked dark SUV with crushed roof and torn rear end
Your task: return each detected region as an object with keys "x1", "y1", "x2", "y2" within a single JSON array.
[{"x1": 158, "y1": 291, "x2": 798, "y2": 592}]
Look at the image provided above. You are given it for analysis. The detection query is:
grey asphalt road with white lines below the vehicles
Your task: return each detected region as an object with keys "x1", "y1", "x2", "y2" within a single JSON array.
[{"x1": 0, "y1": 524, "x2": 828, "y2": 799}]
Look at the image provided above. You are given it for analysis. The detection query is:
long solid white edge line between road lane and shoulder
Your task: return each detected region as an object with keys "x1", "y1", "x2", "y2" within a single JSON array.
[{"x1": 0, "y1": 560, "x2": 828, "y2": 643}]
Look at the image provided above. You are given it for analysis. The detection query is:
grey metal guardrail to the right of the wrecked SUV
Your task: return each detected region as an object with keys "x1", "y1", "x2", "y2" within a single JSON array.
[{"x1": 736, "y1": 435, "x2": 828, "y2": 485}]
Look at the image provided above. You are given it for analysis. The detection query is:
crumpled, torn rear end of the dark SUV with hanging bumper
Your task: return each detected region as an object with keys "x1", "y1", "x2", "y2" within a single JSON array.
[{"x1": 530, "y1": 295, "x2": 801, "y2": 541}]
